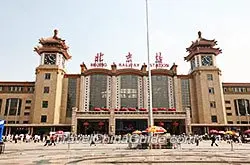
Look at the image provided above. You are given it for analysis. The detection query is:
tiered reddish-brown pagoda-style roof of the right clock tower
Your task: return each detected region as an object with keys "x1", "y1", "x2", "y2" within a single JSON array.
[{"x1": 184, "y1": 31, "x2": 222, "y2": 61}]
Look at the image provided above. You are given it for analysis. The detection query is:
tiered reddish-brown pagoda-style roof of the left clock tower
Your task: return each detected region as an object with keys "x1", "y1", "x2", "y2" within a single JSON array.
[{"x1": 34, "y1": 30, "x2": 71, "y2": 60}]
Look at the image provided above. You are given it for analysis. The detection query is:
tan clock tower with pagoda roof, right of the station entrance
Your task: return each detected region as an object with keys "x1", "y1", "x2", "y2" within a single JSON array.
[{"x1": 184, "y1": 32, "x2": 226, "y2": 124}]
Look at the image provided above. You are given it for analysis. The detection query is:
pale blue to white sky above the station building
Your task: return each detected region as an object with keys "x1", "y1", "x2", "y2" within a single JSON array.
[{"x1": 0, "y1": 0, "x2": 250, "y2": 82}]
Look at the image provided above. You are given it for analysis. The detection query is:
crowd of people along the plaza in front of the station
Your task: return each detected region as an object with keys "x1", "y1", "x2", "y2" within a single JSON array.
[{"x1": 0, "y1": 133, "x2": 246, "y2": 146}]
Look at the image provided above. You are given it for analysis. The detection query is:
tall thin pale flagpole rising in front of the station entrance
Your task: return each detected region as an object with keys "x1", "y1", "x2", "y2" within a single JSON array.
[{"x1": 146, "y1": 0, "x2": 154, "y2": 126}]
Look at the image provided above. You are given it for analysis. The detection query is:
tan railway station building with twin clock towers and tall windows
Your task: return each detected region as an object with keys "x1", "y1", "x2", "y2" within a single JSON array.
[{"x1": 0, "y1": 30, "x2": 250, "y2": 134}]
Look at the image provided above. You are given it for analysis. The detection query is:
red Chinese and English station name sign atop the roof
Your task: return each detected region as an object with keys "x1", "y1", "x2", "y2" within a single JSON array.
[{"x1": 90, "y1": 52, "x2": 169, "y2": 68}]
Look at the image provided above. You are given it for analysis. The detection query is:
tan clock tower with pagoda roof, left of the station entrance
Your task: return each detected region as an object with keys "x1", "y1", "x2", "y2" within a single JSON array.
[{"x1": 31, "y1": 30, "x2": 71, "y2": 124}]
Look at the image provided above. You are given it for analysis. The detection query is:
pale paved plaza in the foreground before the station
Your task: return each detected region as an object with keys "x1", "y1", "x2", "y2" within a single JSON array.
[{"x1": 0, "y1": 141, "x2": 250, "y2": 165}]
